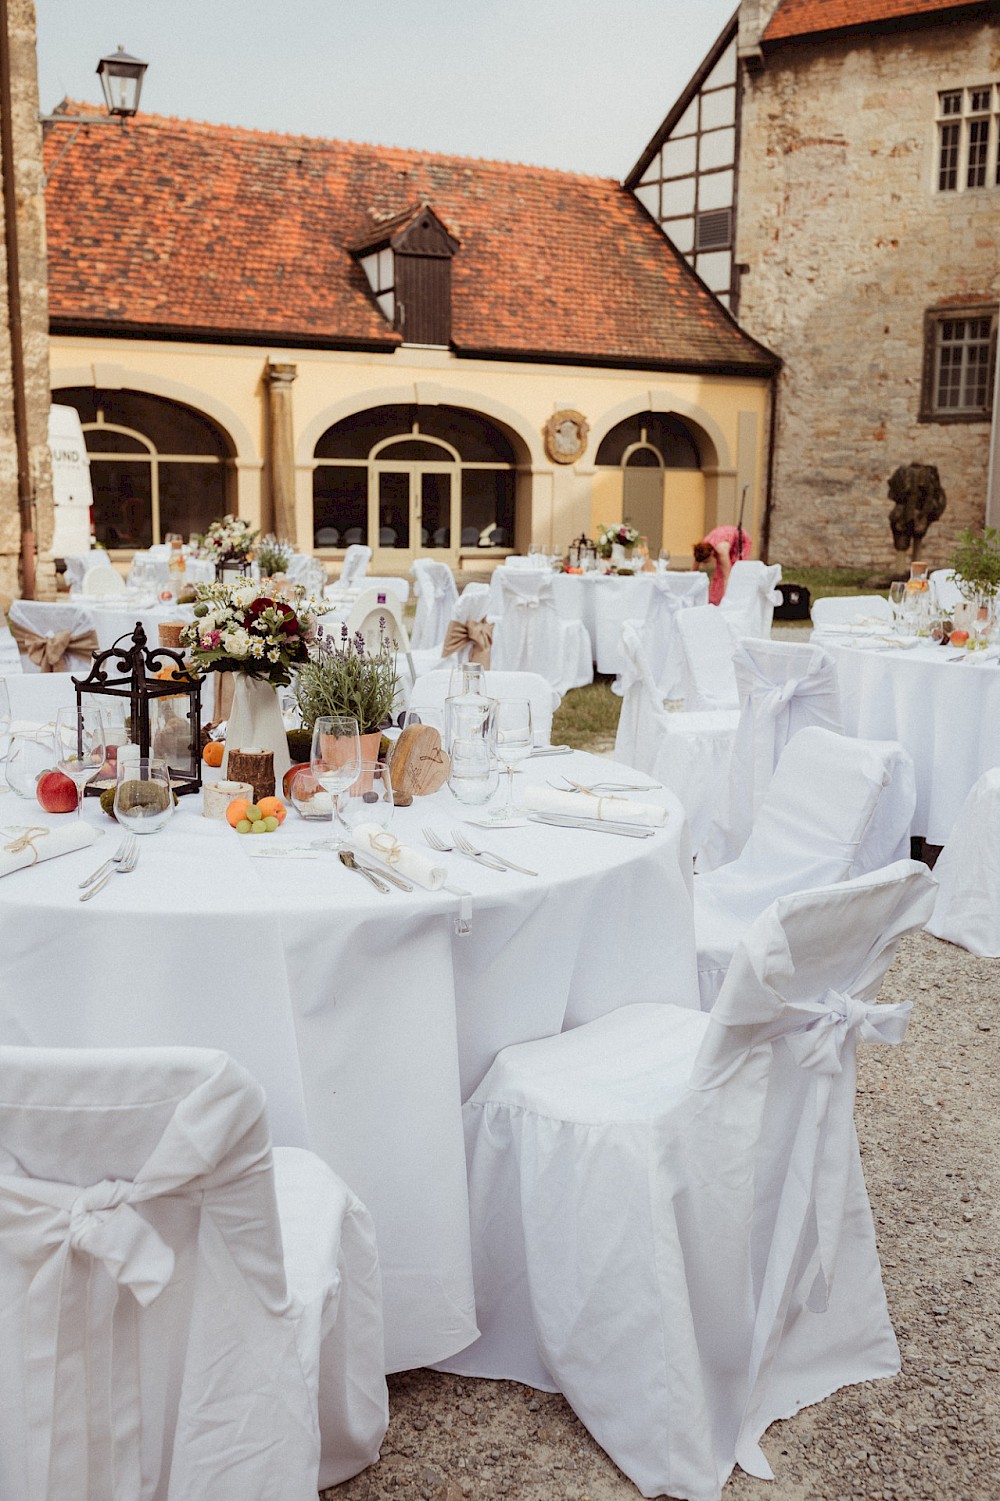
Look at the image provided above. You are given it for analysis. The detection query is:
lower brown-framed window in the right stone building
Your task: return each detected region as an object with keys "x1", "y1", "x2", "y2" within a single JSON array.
[{"x1": 920, "y1": 306, "x2": 997, "y2": 422}]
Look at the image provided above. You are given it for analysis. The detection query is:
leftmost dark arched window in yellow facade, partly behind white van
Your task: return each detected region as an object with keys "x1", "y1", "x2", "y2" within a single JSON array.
[{"x1": 53, "y1": 386, "x2": 231, "y2": 549}]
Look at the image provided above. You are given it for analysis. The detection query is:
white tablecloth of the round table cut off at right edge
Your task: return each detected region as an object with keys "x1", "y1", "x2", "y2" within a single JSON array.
[{"x1": 814, "y1": 632, "x2": 1000, "y2": 845}]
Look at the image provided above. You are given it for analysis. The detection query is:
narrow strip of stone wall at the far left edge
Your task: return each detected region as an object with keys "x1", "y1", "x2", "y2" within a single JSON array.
[{"x1": 0, "y1": 0, "x2": 56, "y2": 597}]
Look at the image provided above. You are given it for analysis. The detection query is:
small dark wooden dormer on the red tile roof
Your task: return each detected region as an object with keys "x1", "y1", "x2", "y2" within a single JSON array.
[{"x1": 353, "y1": 204, "x2": 459, "y2": 347}]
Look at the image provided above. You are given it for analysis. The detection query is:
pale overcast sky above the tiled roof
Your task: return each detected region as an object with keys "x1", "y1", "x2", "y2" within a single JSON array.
[{"x1": 35, "y1": 0, "x2": 736, "y2": 179}]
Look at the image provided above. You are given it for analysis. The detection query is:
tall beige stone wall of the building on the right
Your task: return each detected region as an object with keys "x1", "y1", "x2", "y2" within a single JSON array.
[{"x1": 737, "y1": 20, "x2": 1000, "y2": 567}]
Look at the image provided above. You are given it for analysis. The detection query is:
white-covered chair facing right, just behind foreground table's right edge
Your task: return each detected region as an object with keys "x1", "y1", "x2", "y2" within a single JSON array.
[{"x1": 614, "y1": 621, "x2": 739, "y2": 853}]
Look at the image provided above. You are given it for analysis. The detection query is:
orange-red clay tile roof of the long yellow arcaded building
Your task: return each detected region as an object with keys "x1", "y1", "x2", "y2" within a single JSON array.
[{"x1": 45, "y1": 104, "x2": 776, "y2": 369}]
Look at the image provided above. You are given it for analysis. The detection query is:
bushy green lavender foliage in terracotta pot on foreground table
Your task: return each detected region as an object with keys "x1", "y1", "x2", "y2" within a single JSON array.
[{"x1": 296, "y1": 626, "x2": 399, "y2": 735}]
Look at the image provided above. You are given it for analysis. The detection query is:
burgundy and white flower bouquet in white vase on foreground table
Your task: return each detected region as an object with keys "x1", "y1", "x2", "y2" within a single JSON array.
[{"x1": 180, "y1": 581, "x2": 317, "y2": 784}]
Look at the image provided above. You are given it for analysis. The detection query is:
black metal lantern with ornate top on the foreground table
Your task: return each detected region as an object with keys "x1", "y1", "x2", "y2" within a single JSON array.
[{"x1": 74, "y1": 620, "x2": 203, "y2": 797}]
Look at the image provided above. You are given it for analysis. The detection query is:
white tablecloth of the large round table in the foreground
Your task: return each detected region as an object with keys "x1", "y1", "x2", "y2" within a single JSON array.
[{"x1": 0, "y1": 754, "x2": 698, "y2": 1370}]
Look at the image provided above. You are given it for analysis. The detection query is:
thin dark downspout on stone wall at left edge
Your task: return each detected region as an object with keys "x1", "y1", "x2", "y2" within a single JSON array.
[{"x1": 0, "y1": 0, "x2": 35, "y2": 599}]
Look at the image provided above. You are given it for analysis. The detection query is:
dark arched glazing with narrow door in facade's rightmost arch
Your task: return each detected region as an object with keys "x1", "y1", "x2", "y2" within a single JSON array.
[{"x1": 598, "y1": 411, "x2": 701, "y2": 552}]
